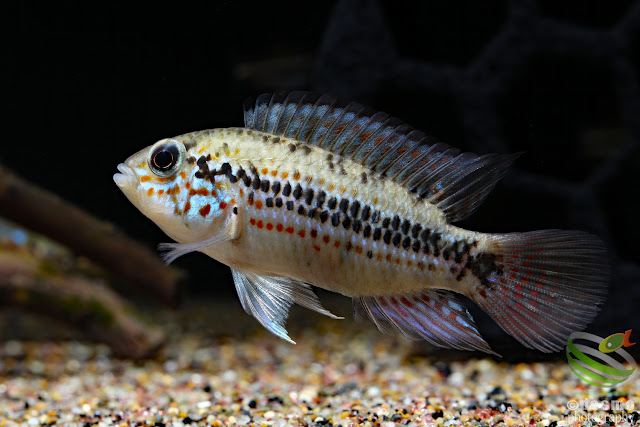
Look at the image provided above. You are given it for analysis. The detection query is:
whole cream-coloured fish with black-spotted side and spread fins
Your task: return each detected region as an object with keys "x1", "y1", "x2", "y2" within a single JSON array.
[{"x1": 113, "y1": 91, "x2": 608, "y2": 354}]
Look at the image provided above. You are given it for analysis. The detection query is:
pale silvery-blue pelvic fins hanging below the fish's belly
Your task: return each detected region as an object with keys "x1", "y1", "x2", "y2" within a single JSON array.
[{"x1": 231, "y1": 268, "x2": 342, "y2": 344}]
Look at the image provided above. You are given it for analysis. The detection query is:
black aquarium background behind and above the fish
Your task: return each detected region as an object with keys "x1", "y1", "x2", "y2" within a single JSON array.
[{"x1": 5, "y1": 0, "x2": 640, "y2": 356}]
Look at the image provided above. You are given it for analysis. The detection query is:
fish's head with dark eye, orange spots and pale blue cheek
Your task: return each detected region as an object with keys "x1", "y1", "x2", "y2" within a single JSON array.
[{"x1": 113, "y1": 135, "x2": 232, "y2": 243}]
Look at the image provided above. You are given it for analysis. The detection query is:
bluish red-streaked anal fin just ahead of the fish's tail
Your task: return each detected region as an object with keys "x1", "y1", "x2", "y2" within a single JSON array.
[{"x1": 353, "y1": 289, "x2": 497, "y2": 354}]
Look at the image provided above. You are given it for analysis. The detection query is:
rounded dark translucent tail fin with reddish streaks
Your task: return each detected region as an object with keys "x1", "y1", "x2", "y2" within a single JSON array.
[{"x1": 468, "y1": 230, "x2": 609, "y2": 352}]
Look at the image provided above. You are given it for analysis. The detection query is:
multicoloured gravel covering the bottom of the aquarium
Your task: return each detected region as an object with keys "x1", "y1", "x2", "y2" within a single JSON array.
[{"x1": 0, "y1": 302, "x2": 640, "y2": 427}]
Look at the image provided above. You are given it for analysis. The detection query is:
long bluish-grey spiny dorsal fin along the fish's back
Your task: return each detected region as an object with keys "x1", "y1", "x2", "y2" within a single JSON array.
[{"x1": 244, "y1": 92, "x2": 518, "y2": 221}]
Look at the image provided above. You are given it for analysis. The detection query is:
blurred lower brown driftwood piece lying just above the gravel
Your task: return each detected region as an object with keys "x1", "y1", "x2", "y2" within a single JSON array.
[{"x1": 0, "y1": 250, "x2": 164, "y2": 359}]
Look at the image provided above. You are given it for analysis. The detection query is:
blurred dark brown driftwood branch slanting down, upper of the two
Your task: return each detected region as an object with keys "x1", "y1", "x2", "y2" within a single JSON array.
[{"x1": 0, "y1": 166, "x2": 181, "y2": 305}]
